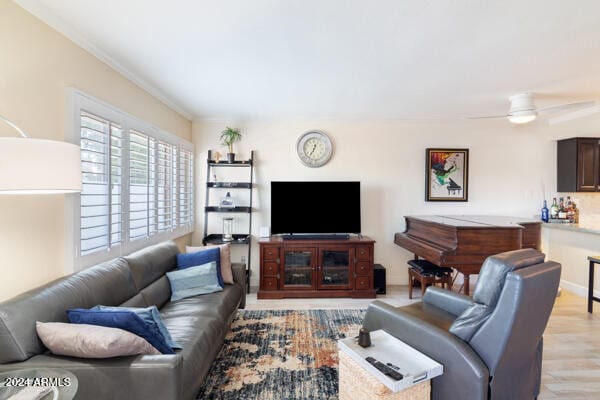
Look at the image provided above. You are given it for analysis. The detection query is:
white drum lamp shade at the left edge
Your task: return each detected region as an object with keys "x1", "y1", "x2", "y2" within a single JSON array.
[{"x1": 0, "y1": 137, "x2": 81, "y2": 194}]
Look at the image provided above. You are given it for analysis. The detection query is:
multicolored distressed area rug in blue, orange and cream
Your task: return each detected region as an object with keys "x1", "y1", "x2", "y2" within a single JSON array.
[{"x1": 198, "y1": 310, "x2": 365, "y2": 400}]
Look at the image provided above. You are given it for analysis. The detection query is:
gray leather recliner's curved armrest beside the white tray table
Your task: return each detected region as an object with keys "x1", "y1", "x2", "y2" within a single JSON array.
[{"x1": 363, "y1": 301, "x2": 489, "y2": 400}]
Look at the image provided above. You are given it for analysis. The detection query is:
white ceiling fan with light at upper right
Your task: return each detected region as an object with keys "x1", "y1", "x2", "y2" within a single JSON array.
[{"x1": 469, "y1": 93, "x2": 596, "y2": 124}]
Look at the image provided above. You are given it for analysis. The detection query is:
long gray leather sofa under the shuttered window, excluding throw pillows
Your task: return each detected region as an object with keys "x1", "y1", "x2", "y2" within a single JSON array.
[{"x1": 0, "y1": 241, "x2": 246, "y2": 400}]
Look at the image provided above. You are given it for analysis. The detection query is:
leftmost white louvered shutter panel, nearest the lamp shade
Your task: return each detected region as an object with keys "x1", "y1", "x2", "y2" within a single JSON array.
[{"x1": 79, "y1": 111, "x2": 123, "y2": 255}]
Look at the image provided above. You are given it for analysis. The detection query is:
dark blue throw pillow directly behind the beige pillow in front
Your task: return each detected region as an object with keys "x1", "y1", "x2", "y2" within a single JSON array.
[{"x1": 67, "y1": 308, "x2": 175, "y2": 354}]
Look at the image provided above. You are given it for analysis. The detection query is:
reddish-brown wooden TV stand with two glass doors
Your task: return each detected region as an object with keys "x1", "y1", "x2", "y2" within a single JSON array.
[{"x1": 257, "y1": 236, "x2": 375, "y2": 299}]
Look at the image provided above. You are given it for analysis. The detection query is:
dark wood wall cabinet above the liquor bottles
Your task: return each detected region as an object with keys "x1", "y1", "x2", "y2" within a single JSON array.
[{"x1": 556, "y1": 138, "x2": 600, "y2": 192}]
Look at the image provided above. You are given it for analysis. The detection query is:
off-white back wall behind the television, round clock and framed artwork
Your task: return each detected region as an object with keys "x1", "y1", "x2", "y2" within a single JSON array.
[{"x1": 192, "y1": 120, "x2": 555, "y2": 285}]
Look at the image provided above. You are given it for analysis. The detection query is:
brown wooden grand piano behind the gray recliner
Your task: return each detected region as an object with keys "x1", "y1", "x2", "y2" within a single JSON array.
[{"x1": 394, "y1": 215, "x2": 541, "y2": 295}]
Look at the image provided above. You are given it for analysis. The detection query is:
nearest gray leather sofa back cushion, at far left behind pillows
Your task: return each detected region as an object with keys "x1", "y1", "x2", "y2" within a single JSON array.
[{"x1": 0, "y1": 259, "x2": 136, "y2": 363}]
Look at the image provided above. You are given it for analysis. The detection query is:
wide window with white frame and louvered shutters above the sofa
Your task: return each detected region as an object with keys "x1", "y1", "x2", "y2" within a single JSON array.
[{"x1": 72, "y1": 91, "x2": 194, "y2": 268}]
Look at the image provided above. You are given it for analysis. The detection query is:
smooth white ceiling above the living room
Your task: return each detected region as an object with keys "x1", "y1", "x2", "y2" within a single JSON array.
[{"x1": 16, "y1": 0, "x2": 600, "y2": 119}]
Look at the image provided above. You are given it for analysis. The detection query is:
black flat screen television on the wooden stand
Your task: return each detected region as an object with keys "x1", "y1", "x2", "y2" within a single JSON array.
[{"x1": 271, "y1": 181, "x2": 361, "y2": 235}]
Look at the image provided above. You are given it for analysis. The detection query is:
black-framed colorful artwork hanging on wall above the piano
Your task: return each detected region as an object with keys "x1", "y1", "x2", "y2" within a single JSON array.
[{"x1": 425, "y1": 148, "x2": 469, "y2": 201}]
